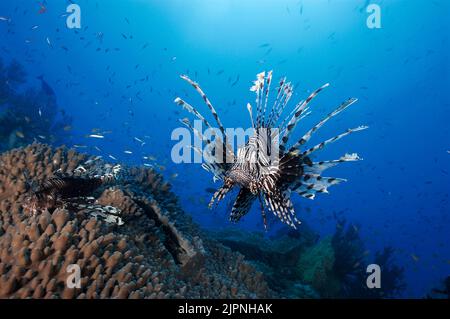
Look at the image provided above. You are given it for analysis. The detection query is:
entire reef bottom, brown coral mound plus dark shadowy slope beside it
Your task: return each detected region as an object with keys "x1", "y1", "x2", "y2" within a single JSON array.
[{"x1": 0, "y1": 143, "x2": 418, "y2": 298}]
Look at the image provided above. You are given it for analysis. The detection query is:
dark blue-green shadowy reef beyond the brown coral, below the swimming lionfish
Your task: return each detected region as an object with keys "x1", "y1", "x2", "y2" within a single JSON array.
[{"x1": 212, "y1": 219, "x2": 405, "y2": 298}]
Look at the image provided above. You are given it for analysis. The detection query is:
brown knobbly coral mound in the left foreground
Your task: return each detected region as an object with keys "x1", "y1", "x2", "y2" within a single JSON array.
[{"x1": 0, "y1": 144, "x2": 272, "y2": 298}]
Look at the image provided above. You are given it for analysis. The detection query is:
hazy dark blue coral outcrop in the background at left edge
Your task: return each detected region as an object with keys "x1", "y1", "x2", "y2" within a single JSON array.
[{"x1": 0, "y1": 59, "x2": 72, "y2": 151}]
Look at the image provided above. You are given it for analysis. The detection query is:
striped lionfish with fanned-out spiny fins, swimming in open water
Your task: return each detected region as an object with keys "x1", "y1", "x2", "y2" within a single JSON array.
[{"x1": 174, "y1": 71, "x2": 367, "y2": 229}]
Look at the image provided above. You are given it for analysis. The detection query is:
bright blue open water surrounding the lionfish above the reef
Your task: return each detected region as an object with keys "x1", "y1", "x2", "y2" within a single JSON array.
[{"x1": 0, "y1": 0, "x2": 450, "y2": 297}]
